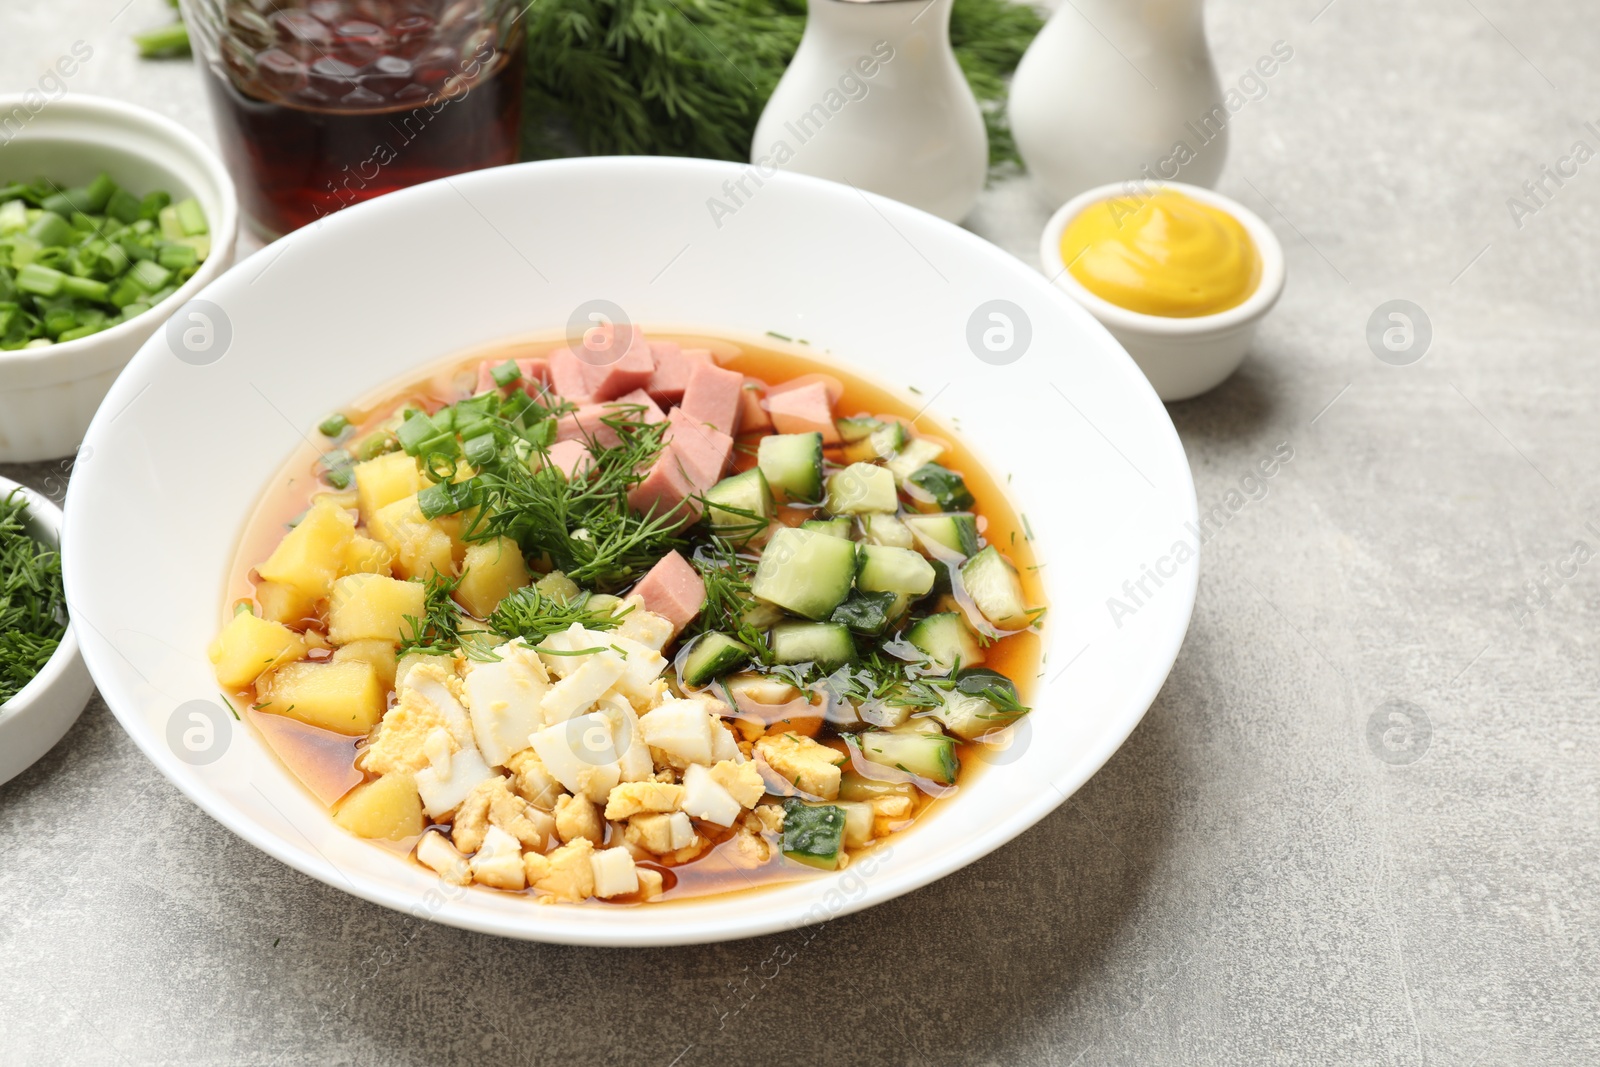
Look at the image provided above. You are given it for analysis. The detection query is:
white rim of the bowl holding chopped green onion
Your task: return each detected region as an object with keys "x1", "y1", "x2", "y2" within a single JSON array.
[{"x1": 0, "y1": 93, "x2": 238, "y2": 378}]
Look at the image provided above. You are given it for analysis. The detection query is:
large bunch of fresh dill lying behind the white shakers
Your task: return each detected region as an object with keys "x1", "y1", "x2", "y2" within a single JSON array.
[{"x1": 523, "y1": 0, "x2": 1042, "y2": 166}]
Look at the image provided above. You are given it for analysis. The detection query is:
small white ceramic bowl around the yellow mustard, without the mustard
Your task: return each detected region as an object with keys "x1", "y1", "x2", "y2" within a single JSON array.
[{"x1": 1038, "y1": 181, "x2": 1285, "y2": 400}]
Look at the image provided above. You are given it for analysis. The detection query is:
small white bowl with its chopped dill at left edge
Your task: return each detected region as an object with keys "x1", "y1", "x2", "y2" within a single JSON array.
[{"x1": 0, "y1": 478, "x2": 94, "y2": 784}]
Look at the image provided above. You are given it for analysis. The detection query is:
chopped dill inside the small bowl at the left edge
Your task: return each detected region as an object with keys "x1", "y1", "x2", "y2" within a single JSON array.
[{"x1": 0, "y1": 491, "x2": 67, "y2": 704}]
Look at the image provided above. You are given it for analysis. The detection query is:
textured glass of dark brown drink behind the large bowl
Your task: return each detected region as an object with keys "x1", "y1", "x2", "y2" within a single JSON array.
[{"x1": 184, "y1": 0, "x2": 525, "y2": 237}]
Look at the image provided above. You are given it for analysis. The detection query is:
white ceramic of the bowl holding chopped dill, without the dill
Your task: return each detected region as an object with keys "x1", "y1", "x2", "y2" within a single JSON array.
[{"x1": 0, "y1": 478, "x2": 94, "y2": 784}]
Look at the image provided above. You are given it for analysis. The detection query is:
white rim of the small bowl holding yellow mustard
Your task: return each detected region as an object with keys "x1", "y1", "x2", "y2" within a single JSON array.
[{"x1": 1038, "y1": 179, "x2": 1286, "y2": 338}]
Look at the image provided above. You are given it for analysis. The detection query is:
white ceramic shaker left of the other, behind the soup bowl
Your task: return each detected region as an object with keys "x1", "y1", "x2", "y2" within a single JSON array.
[{"x1": 750, "y1": 0, "x2": 989, "y2": 222}]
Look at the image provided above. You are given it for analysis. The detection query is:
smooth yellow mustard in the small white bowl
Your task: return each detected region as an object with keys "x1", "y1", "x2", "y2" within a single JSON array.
[{"x1": 1061, "y1": 189, "x2": 1261, "y2": 318}]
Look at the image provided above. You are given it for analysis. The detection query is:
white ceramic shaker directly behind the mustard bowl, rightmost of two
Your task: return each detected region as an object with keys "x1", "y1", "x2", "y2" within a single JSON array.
[{"x1": 1010, "y1": 0, "x2": 1230, "y2": 206}]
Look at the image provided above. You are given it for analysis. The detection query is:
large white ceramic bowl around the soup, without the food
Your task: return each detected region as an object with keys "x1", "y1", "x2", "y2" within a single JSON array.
[{"x1": 66, "y1": 157, "x2": 1195, "y2": 945}]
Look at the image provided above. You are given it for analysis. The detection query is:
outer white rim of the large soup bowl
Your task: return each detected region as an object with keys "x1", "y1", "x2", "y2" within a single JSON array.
[{"x1": 66, "y1": 157, "x2": 1198, "y2": 947}]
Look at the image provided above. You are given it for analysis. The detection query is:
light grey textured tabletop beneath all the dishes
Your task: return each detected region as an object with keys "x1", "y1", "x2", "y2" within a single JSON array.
[{"x1": 0, "y1": 0, "x2": 1600, "y2": 1067}]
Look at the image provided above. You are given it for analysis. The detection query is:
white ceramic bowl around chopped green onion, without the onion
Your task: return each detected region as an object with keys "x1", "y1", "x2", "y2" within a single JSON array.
[{"x1": 0, "y1": 93, "x2": 238, "y2": 462}]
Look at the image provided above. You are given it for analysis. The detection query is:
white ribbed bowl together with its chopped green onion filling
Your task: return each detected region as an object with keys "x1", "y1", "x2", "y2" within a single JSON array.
[{"x1": 0, "y1": 94, "x2": 238, "y2": 462}]
